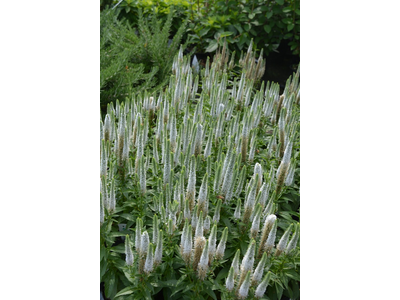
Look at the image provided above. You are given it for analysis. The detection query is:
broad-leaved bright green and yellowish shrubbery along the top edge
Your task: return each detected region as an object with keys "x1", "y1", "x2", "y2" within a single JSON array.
[{"x1": 110, "y1": 0, "x2": 300, "y2": 58}]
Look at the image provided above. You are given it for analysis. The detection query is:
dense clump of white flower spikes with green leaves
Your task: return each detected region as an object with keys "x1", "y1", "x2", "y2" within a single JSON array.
[{"x1": 100, "y1": 42, "x2": 300, "y2": 300}]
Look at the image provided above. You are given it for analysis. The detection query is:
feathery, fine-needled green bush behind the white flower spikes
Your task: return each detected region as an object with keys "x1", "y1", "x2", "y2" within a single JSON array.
[{"x1": 100, "y1": 9, "x2": 185, "y2": 105}]
